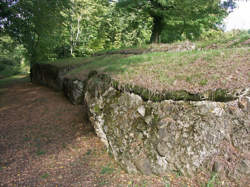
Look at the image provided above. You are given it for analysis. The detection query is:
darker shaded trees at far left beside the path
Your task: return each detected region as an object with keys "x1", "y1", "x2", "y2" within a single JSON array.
[{"x1": 0, "y1": 0, "x2": 69, "y2": 63}]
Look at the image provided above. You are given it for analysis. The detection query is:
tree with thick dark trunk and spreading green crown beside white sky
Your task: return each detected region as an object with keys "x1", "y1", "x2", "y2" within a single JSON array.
[{"x1": 118, "y1": 0, "x2": 229, "y2": 43}]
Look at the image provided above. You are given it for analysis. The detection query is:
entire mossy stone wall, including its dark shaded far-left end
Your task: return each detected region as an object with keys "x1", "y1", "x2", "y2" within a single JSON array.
[{"x1": 32, "y1": 65, "x2": 250, "y2": 179}]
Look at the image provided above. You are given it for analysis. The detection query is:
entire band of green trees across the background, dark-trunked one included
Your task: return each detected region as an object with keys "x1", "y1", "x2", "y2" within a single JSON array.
[{"x1": 0, "y1": 0, "x2": 237, "y2": 63}]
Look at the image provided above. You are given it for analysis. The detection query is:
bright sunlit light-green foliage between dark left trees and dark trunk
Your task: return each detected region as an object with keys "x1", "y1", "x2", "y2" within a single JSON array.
[{"x1": 63, "y1": 0, "x2": 151, "y2": 56}]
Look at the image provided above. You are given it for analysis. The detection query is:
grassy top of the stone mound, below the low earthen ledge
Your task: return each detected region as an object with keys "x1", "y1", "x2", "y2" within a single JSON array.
[{"x1": 59, "y1": 48, "x2": 250, "y2": 93}]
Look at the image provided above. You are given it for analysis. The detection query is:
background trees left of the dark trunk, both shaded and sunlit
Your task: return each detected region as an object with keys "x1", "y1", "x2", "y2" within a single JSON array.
[{"x1": 0, "y1": 0, "x2": 151, "y2": 63}]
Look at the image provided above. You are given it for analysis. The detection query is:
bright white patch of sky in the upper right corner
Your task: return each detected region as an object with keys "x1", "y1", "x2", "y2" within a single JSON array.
[{"x1": 224, "y1": 0, "x2": 250, "y2": 31}]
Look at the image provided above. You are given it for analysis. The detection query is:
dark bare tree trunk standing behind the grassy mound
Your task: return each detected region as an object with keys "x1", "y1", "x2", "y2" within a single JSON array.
[{"x1": 150, "y1": 16, "x2": 163, "y2": 43}]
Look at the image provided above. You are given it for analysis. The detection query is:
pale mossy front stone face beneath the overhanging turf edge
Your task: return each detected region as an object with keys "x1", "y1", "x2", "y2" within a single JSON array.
[{"x1": 85, "y1": 75, "x2": 250, "y2": 179}]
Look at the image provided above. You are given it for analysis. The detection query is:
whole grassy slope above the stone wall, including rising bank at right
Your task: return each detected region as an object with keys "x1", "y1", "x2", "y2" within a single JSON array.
[{"x1": 49, "y1": 32, "x2": 250, "y2": 93}]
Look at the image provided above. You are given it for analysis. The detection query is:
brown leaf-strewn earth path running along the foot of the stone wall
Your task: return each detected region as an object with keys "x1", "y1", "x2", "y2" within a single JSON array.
[{"x1": 0, "y1": 82, "x2": 242, "y2": 187}]
